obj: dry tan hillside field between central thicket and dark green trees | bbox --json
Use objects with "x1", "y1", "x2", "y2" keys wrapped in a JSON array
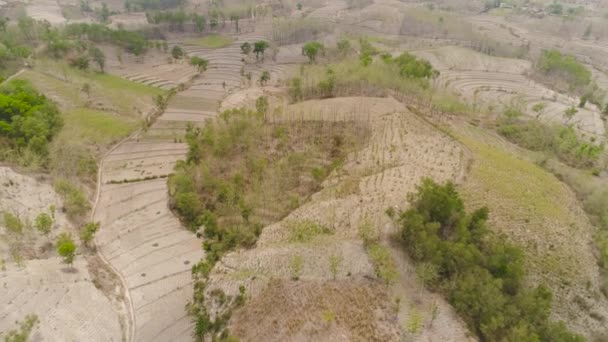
[{"x1": 207, "y1": 98, "x2": 467, "y2": 341}]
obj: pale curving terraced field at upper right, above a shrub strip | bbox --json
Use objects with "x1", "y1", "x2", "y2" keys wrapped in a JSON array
[{"x1": 415, "y1": 47, "x2": 606, "y2": 138}]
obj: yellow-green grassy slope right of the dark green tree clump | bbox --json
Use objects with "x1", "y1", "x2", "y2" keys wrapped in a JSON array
[{"x1": 453, "y1": 127, "x2": 589, "y2": 282}]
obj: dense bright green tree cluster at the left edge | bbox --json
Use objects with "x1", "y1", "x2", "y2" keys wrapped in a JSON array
[{"x1": 0, "y1": 80, "x2": 63, "y2": 164}]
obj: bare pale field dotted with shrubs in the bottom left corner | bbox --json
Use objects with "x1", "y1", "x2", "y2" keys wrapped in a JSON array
[{"x1": 0, "y1": 167, "x2": 122, "y2": 341}]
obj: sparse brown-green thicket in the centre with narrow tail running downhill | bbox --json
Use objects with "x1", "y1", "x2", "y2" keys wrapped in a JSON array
[{"x1": 175, "y1": 106, "x2": 368, "y2": 341}]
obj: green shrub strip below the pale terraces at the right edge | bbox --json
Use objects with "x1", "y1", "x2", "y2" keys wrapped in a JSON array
[{"x1": 498, "y1": 109, "x2": 604, "y2": 167}]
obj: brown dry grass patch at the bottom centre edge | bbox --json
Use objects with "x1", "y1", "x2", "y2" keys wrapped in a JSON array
[{"x1": 229, "y1": 279, "x2": 399, "y2": 341}]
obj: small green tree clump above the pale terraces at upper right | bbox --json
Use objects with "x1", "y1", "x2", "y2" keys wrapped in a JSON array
[{"x1": 537, "y1": 50, "x2": 591, "y2": 93}]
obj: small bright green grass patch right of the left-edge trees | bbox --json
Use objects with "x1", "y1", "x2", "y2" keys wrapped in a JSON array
[{"x1": 61, "y1": 108, "x2": 138, "y2": 144}]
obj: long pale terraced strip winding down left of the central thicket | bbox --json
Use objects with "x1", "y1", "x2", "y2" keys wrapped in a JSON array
[{"x1": 94, "y1": 22, "x2": 276, "y2": 341}]
